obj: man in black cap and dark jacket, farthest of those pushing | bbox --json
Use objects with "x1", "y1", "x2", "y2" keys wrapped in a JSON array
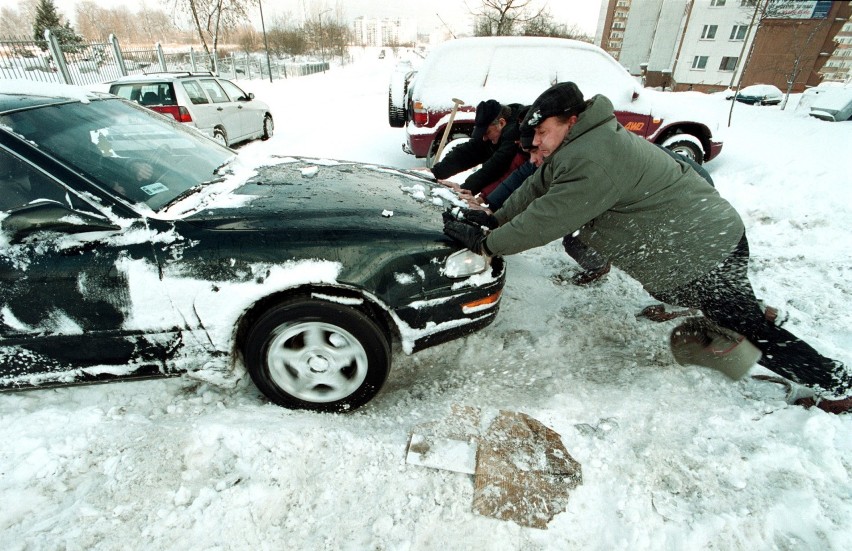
[{"x1": 432, "y1": 99, "x2": 527, "y2": 195}]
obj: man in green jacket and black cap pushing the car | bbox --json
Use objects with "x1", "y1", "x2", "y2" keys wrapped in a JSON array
[{"x1": 444, "y1": 82, "x2": 852, "y2": 413}]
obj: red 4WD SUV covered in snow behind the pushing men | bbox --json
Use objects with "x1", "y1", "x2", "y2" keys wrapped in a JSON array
[{"x1": 388, "y1": 37, "x2": 722, "y2": 164}]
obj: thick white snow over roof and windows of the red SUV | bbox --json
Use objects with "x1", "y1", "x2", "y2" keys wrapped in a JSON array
[{"x1": 414, "y1": 37, "x2": 639, "y2": 109}]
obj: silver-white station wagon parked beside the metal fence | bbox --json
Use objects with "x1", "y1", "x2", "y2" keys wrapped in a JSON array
[{"x1": 109, "y1": 72, "x2": 275, "y2": 146}]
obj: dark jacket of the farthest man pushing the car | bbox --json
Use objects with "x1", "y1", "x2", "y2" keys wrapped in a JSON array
[{"x1": 432, "y1": 103, "x2": 526, "y2": 195}]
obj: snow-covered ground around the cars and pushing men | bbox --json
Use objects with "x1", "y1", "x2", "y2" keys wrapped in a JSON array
[{"x1": 0, "y1": 49, "x2": 852, "y2": 551}]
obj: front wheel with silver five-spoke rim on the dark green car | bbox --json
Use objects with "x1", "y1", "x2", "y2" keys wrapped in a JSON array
[{"x1": 243, "y1": 299, "x2": 391, "y2": 411}]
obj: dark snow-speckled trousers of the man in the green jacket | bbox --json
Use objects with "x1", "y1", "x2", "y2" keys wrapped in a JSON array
[{"x1": 654, "y1": 235, "x2": 852, "y2": 398}]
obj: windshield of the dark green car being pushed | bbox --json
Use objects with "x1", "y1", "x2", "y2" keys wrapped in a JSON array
[{"x1": 0, "y1": 99, "x2": 234, "y2": 210}]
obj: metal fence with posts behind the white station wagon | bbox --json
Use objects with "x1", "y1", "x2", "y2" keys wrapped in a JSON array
[{"x1": 0, "y1": 30, "x2": 329, "y2": 86}]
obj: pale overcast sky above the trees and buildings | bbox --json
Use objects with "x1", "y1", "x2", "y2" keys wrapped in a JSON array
[{"x1": 50, "y1": 0, "x2": 601, "y2": 36}]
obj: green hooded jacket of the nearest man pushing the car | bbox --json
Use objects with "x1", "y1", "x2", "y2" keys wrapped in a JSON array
[{"x1": 486, "y1": 95, "x2": 745, "y2": 294}]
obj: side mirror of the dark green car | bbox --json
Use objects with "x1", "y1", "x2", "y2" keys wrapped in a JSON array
[{"x1": 0, "y1": 199, "x2": 121, "y2": 241}]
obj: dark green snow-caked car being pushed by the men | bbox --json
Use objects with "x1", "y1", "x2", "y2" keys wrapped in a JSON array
[{"x1": 0, "y1": 80, "x2": 505, "y2": 411}]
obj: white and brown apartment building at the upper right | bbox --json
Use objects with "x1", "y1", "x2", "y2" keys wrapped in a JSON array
[{"x1": 596, "y1": 0, "x2": 852, "y2": 92}]
